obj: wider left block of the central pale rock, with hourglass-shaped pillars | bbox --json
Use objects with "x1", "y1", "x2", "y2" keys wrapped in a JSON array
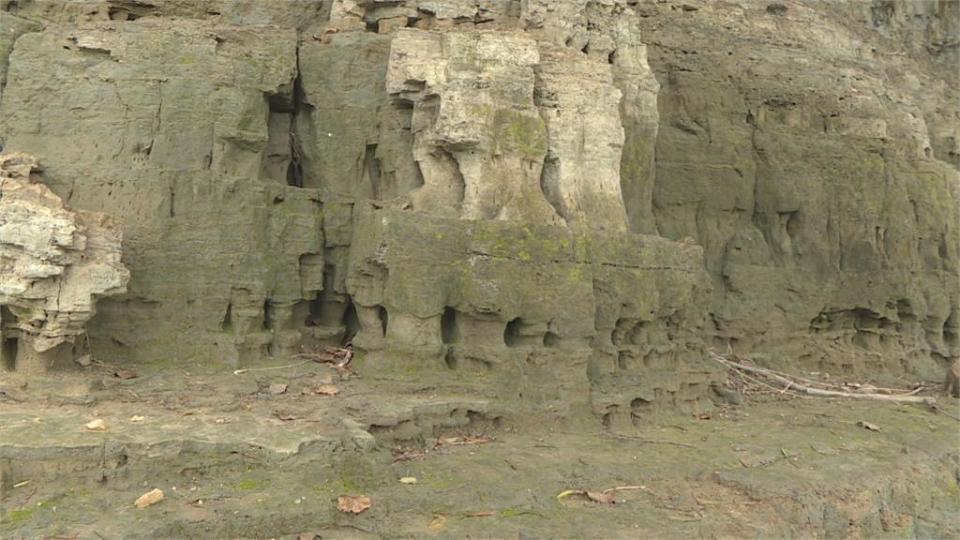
[{"x1": 387, "y1": 30, "x2": 560, "y2": 223}]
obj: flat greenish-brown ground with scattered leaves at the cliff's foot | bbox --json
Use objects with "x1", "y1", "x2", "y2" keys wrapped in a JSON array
[{"x1": 0, "y1": 358, "x2": 960, "y2": 539}]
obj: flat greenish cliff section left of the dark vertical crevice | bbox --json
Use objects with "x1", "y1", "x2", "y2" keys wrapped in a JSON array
[{"x1": 0, "y1": 19, "x2": 323, "y2": 370}]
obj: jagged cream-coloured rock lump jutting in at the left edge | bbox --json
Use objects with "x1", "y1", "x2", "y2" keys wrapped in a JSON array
[{"x1": 0, "y1": 154, "x2": 130, "y2": 367}]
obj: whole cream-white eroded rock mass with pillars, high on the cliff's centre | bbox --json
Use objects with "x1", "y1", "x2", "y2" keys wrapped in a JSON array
[{"x1": 386, "y1": 24, "x2": 640, "y2": 231}]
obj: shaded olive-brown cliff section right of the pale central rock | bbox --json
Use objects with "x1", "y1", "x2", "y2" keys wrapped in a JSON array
[{"x1": 637, "y1": 1, "x2": 960, "y2": 378}]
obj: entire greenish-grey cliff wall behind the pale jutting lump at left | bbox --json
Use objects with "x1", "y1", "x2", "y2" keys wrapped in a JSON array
[{"x1": 0, "y1": 0, "x2": 960, "y2": 423}]
